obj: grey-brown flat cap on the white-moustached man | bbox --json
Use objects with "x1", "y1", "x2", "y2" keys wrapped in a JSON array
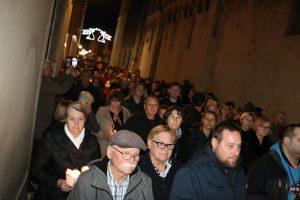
[{"x1": 110, "y1": 130, "x2": 147, "y2": 151}]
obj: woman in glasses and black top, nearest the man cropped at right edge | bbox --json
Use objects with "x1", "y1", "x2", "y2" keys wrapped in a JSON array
[{"x1": 242, "y1": 117, "x2": 272, "y2": 171}]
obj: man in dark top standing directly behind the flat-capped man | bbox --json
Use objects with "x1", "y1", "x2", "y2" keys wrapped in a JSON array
[{"x1": 123, "y1": 96, "x2": 160, "y2": 142}]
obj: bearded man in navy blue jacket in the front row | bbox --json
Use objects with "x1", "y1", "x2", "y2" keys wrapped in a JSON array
[{"x1": 170, "y1": 121, "x2": 246, "y2": 200}]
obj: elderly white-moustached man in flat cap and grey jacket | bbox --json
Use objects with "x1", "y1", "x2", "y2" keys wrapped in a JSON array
[{"x1": 68, "y1": 130, "x2": 153, "y2": 200}]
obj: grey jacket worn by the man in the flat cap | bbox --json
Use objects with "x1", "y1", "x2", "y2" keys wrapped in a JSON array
[{"x1": 68, "y1": 157, "x2": 153, "y2": 200}]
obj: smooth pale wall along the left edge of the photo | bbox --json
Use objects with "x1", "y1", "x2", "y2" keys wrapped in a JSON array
[{"x1": 0, "y1": 0, "x2": 55, "y2": 199}]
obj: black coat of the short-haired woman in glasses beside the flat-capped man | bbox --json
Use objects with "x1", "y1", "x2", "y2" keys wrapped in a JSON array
[{"x1": 139, "y1": 154, "x2": 181, "y2": 200}]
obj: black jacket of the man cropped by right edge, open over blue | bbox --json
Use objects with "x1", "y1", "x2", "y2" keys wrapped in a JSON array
[{"x1": 247, "y1": 148, "x2": 289, "y2": 200}]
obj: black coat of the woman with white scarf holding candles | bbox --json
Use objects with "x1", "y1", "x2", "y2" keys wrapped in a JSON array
[{"x1": 31, "y1": 126, "x2": 100, "y2": 200}]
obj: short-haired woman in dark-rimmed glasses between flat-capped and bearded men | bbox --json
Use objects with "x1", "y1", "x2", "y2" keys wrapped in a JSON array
[{"x1": 139, "y1": 125, "x2": 181, "y2": 200}]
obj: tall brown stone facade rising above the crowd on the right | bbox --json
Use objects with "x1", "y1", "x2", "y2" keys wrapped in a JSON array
[{"x1": 113, "y1": 0, "x2": 300, "y2": 122}]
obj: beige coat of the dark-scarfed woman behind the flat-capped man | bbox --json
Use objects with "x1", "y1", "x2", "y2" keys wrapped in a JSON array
[{"x1": 96, "y1": 106, "x2": 130, "y2": 157}]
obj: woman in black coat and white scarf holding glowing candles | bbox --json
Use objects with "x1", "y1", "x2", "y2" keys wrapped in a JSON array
[{"x1": 31, "y1": 102, "x2": 100, "y2": 200}]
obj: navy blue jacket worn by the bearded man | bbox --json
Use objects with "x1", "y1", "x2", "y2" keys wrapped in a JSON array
[{"x1": 170, "y1": 144, "x2": 246, "y2": 200}]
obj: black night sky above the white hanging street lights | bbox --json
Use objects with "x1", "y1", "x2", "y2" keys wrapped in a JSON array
[{"x1": 83, "y1": 0, "x2": 122, "y2": 35}]
